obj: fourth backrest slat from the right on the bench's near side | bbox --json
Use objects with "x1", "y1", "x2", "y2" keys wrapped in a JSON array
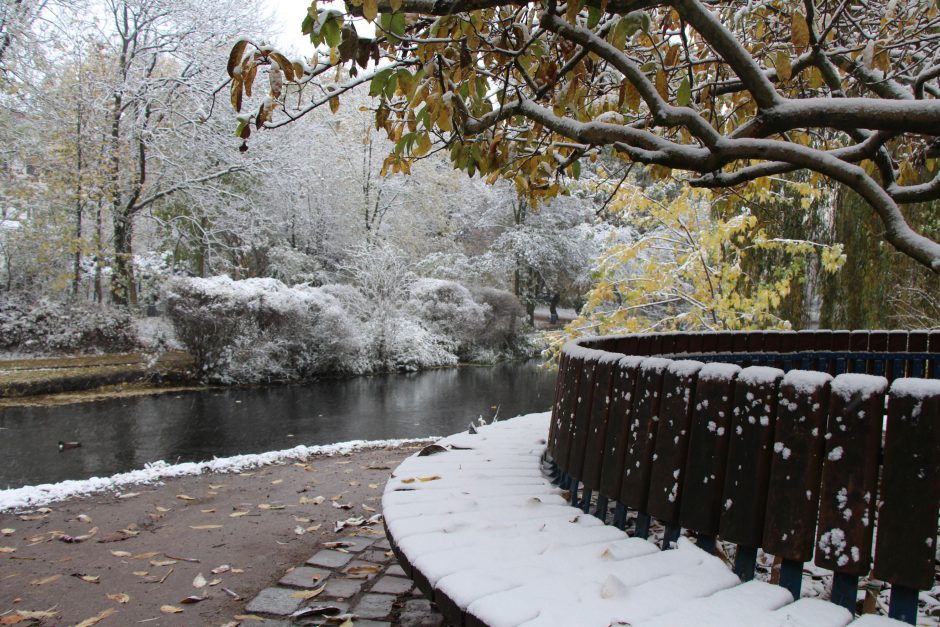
[{"x1": 719, "y1": 366, "x2": 783, "y2": 548}]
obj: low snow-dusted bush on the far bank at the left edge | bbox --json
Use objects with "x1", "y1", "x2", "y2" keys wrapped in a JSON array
[{"x1": 0, "y1": 294, "x2": 138, "y2": 354}]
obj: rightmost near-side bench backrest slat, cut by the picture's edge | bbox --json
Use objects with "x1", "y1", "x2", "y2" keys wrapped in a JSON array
[{"x1": 875, "y1": 379, "x2": 940, "y2": 590}]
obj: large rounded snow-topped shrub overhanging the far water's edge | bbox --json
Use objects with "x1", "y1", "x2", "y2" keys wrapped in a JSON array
[{"x1": 165, "y1": 276, "x2": 365, "y2": 383}]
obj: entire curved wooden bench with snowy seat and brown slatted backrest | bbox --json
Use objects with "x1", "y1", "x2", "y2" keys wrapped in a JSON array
[{"x1": 383, "y1": 332, "x2": 940, "y2": 626}]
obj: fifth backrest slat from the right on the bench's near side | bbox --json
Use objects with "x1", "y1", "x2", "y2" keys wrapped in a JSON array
[{"x1": 679, "y1": 364, "x2": 741, "y2": 535}]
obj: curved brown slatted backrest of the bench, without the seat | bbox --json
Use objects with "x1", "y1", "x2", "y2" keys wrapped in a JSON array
[{"x1": 549, "y1": 331, "x2": 940, "y2": 621}]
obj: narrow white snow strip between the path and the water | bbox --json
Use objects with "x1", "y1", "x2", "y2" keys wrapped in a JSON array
[{"x1": 0, "y1": 436, "x2": 439, "y2": 512}]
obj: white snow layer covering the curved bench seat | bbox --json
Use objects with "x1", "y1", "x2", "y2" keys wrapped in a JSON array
[{"x1": 382, "y1": 413, "x2": 860, "y2": 627}]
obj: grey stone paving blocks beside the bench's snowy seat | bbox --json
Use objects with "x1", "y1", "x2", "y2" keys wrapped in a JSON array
[{"x1": 241, "y1": 529, "x2": 444, "y2": 627}]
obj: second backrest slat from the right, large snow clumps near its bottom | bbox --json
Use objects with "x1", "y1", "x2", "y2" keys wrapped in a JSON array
[{"x1": 815, "y1": 374, "x2": 887, "y2": 576}]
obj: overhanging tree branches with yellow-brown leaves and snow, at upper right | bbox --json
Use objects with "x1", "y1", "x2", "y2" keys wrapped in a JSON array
[{"x1": 228, "y1": 0, "x2": 940, "y2": 272}]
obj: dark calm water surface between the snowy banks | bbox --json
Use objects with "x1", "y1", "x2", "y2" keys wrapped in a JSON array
[{"x1": 0, "y1": 362, "x2": 555, "y2": 489}]
